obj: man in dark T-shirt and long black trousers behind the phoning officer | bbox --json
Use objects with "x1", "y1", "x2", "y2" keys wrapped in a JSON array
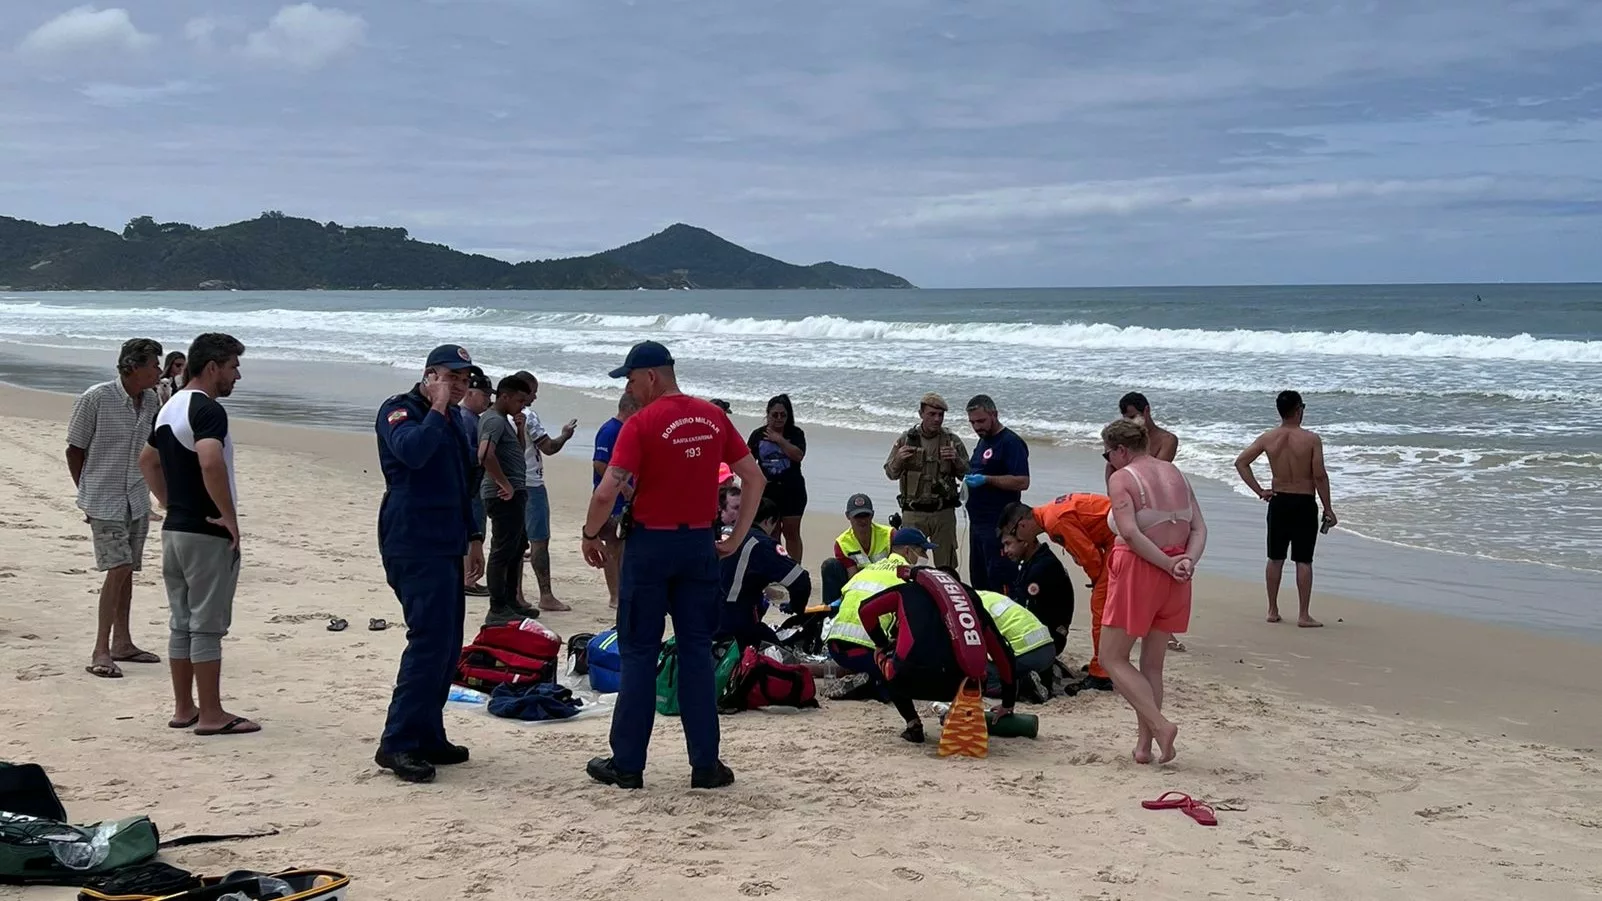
[{"x1": 477, "y1": 375, "x2": 540, "y2": 625}]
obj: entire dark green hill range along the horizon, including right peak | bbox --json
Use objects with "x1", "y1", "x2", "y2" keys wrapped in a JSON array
[{"x1": 0, "y1": 212, "x2": 912, "y2": 290}]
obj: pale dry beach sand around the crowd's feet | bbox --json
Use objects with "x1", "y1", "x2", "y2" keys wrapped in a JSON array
[{"x1": 0, "y1": 380, "x2": 1602, "y2": 901}]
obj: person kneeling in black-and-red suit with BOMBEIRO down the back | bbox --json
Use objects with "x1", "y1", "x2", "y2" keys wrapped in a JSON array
[{"x1": 862, "y1": 568, "x2": 1012, "y2": 744}]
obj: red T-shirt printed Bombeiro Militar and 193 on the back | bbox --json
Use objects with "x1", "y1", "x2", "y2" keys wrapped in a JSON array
[{"x1": 610, "y1": 394, "x2": 751, "y2": 529}]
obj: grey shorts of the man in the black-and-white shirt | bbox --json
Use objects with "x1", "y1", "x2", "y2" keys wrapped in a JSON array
[{"x1": 162, "y1": 531, "x2": 239, "y2": 664}]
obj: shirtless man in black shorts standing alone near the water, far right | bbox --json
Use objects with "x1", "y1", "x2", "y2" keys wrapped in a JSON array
[{"x1": 1235, "y1": 391, "x2": 1339, "y2": 628}]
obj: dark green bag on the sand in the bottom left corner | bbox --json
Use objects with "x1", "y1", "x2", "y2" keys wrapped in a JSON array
[{"x1": 0, "y1": 811, "x2": 160, "y2": 885}]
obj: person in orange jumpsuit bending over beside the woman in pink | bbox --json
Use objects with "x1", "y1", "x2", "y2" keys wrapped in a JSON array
[{"x1": 1000, "y1": 494, "x2": 1117, "y2": 691}]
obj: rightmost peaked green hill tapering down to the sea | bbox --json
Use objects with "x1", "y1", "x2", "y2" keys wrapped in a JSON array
[{"x1": 601, "y1": 223, "x2": 913, "y2": 289}]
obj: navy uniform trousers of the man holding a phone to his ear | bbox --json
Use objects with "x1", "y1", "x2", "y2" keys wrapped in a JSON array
[{"x1": 378, "y1": 556, "x2": 468, "y2": 754}]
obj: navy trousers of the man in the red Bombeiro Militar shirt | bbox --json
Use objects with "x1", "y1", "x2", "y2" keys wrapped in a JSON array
[{"x1": 612, "y1": 526, "x2": 721, "y2": 773}]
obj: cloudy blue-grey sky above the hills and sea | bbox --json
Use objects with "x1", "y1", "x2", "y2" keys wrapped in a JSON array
[{"x1": 0, "y1": 0, "x2": 1602, "y2": 287}]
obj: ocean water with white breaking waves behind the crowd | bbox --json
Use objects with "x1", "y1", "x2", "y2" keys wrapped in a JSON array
[{"x1": 0, "y1": 285, "x2": 1602, "y2": 571}]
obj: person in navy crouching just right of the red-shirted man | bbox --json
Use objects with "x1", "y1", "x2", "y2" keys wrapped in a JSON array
[{"x1": 713, "y1": 497, "x2": 812, "y2": 648}]
